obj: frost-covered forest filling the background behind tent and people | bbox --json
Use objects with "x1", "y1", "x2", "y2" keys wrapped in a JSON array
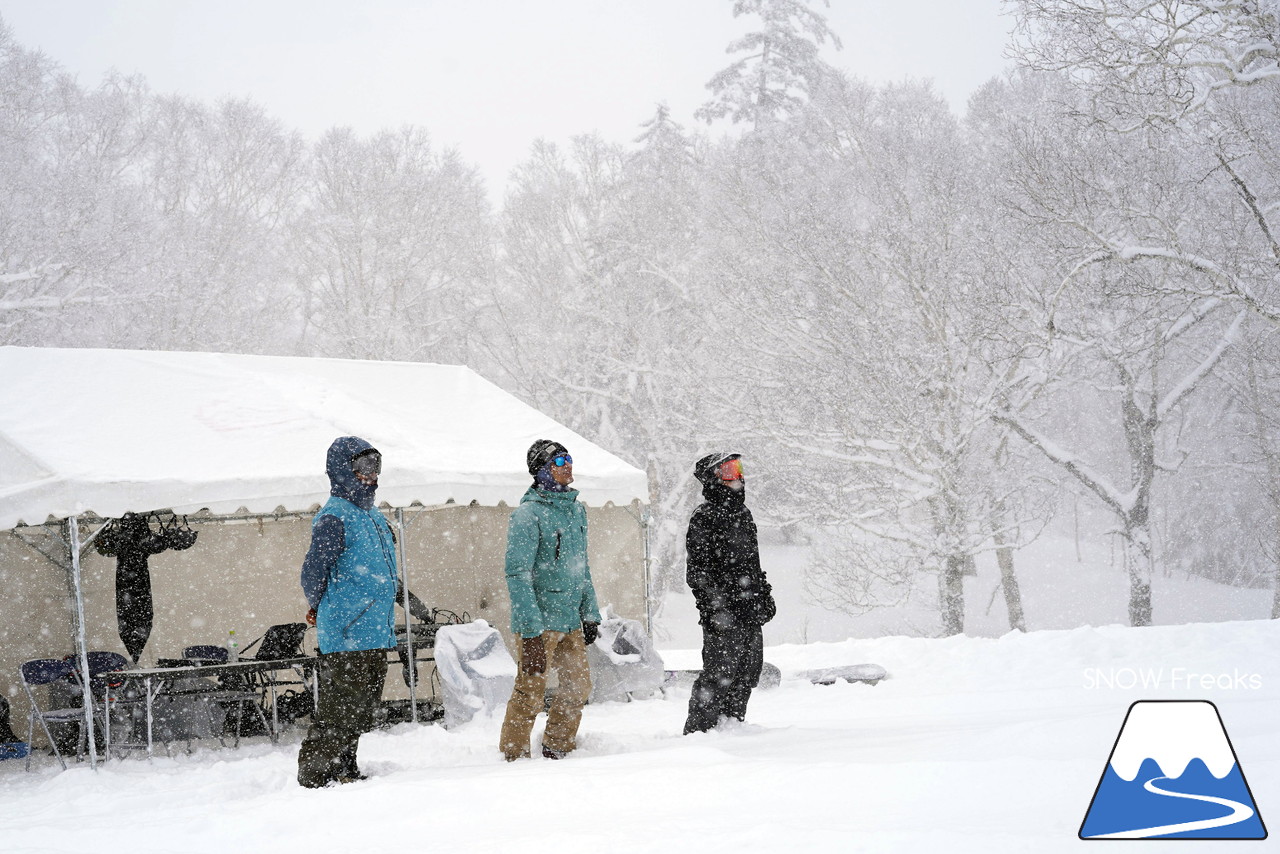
[{"x1": 0, "y1": 0, "x2": 1280, "y2": 634}]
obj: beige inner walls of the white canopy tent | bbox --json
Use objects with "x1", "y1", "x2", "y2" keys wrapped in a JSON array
[{"x1": 0, "y1": 502, "x2": 645, "y2": 743}]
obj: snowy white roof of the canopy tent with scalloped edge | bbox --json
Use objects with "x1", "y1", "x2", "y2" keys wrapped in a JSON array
[{"x1": 0, "y1": 347, "x2": 648, "y2": 530}]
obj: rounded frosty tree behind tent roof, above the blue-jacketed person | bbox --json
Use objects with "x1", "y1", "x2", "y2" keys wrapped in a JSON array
[{"x1": 293, "y1": 128, "x2": 490, "y2": 362}]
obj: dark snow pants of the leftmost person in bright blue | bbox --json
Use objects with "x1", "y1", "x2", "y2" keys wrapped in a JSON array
[{"x1": 298, "y1": 649, "x2": 387, "y2": 789}]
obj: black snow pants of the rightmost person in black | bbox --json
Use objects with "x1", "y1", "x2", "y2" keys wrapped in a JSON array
[{"x1": 685, "y1": 625, "x2": 764, "y2": 735}]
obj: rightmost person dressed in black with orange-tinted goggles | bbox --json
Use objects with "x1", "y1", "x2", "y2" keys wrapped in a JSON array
[{"x1": 685, "y1": 453, "x2": 777, "y2": 735}]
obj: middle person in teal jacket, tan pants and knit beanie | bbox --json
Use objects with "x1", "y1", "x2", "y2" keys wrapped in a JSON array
[{"x1": 499, "y1": 439, "x2": 600, "y2": 762}]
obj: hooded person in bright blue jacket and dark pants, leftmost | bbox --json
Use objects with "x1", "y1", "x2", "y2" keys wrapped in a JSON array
[{"x1": 298, "y1": 437, "x2": 430, "y2": 789}]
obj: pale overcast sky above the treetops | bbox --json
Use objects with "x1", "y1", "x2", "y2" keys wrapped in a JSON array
[{"x1": 0, "y1": 0, "x2": 1010, "y2": 197}]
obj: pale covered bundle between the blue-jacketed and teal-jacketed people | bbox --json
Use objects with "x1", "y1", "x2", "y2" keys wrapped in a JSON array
[{"x1": 435, "y1": 620, "x2": 516, "y2": 729}]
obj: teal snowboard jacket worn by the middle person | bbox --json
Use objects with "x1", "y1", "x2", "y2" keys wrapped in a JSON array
[{"x1": 507, "y1": 487, "x2": 600, "y2": 638}]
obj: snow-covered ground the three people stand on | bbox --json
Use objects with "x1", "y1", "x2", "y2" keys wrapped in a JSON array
[{"x1": 0, "y1": 530, "x2": 1280, "y2": 854}]
